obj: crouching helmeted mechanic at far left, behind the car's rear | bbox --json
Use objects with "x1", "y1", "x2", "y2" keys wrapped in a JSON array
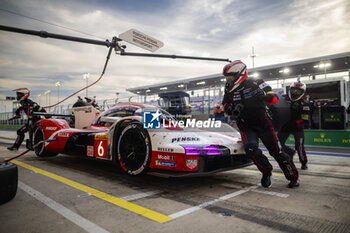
[{"x1": 7, "y1": 88, "x2": 46, "y2": 150}]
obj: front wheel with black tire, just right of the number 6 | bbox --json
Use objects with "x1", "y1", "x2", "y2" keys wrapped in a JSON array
[{"x1": 117, "y1": 122, "x2": 152, "y2": 176}]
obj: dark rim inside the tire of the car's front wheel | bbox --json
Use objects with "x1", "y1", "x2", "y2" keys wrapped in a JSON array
[{"x1": 119, "y1": 128, "x2": 147, "y2": 171}]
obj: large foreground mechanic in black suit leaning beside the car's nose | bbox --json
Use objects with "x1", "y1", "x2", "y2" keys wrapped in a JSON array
[{"x1": 222, "y1": 60, "x2": 299, "y2": 188}]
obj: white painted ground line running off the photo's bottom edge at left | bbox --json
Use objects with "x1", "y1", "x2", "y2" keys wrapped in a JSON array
[{"x1": 18, "y1": 181, "x2": 109, "y2": 233}]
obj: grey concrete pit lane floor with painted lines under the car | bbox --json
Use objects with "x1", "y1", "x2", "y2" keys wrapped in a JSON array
[{"x1": 0, "y1": 131, "x2": 350, "y2": 232}]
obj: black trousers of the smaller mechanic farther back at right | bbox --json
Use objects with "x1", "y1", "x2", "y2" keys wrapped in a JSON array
[{"x1": 278, "y1": 121, "x2": 307, "y2": 165}]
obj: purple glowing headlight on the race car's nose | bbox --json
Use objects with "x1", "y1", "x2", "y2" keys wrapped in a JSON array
[{"x1": 182, "y1": 145, "x2": 230, "y2": 155}]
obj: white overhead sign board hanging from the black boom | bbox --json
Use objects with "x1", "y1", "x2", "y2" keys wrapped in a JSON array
[{"x1": 119, "y1": 29, "x2": 164, "y2": 52}]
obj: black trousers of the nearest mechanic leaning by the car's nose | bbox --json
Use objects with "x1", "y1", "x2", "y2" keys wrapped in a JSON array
[{"x1": 237, "y1": 117, "x2": 298, "y2": 181}]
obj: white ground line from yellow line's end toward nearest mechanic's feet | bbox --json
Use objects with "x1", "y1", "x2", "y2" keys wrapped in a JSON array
[{"x1": 169, "y1": 185, "x2": 259, "y2": 218}]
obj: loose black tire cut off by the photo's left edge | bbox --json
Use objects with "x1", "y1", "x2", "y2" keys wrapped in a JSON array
[{"x1": 0, "y1": 163, "x2": 18, "y2": 205}]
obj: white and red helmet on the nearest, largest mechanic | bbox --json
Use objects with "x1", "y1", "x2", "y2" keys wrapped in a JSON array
[{"x1": 222, "y1": 60, "x2": 248, "y2": 92}]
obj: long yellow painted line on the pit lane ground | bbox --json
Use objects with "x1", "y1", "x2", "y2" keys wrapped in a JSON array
[{"x1": 12, "y1": 160, "x2": 172, "y2": 223}]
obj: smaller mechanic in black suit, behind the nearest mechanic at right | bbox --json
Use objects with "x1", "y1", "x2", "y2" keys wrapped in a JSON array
[{"x1": 278, "y1": 81, "x2": 307, "y2": 170}]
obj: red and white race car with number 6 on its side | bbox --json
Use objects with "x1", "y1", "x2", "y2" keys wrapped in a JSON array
[{"x1": 32, "y1": 103, "x2": 252, "y2": 177}]
